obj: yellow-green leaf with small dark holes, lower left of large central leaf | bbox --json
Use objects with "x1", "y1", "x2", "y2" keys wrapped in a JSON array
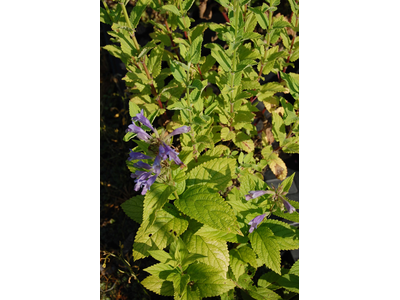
[{"x1": 133, "y1": 206, "x2": 189, "y2": 261}]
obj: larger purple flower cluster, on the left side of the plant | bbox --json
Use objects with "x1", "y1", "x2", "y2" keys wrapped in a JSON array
[{"x1": 127, "y1": 110, "x2": 190, "y2": 195}]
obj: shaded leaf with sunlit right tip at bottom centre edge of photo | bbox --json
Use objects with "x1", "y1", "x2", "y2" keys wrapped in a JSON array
[{"x1": 186, "y1": 263, "x2": 235, "y2": 298}]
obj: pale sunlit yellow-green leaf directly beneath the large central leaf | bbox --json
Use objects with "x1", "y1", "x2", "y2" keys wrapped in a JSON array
[{"x1": 185, "y1": 234, "x2": 229, "y2": 278}]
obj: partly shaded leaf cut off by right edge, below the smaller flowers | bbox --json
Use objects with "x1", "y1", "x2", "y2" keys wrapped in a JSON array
[{"x1": 263, "y1": 219, "x2": 299, "y2": 250}]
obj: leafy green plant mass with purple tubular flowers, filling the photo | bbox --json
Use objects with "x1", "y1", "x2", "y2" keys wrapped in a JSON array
[{"x1": 101, "y1": 0, "x2": 299, "y2": 299}]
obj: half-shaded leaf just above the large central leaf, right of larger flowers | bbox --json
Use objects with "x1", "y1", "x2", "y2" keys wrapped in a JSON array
[{"x1": 186, "y1": 158, "x2": 236, "y2": 190}]
